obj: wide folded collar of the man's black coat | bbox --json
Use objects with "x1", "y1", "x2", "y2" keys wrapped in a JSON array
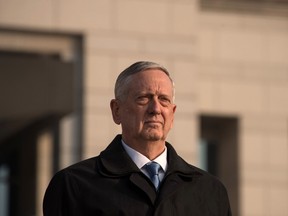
[{"x1": 98, "y1": 135, "x2": 201, "y2": 203}]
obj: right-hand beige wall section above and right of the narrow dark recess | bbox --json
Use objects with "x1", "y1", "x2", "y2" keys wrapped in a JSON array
[{"x1": 197, "y1": 12, "x2": 288, "y2": 216}]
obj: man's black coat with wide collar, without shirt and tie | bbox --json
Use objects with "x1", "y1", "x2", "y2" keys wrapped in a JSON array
[{"x1": 43, "y1": 135, "x2": 231, "y2": 216}]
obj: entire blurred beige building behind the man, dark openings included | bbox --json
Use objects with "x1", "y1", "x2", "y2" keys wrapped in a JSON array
[{"x1": 0, "y1": 0, "x2": 288, "y2": 216}]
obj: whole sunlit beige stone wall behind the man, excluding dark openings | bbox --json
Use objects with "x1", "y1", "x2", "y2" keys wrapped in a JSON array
[{"x1": 0, "y1": 0, "x2": 288, "y2": 216}]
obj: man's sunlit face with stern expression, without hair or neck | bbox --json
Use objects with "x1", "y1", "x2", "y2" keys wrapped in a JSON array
[{"x1": 112, "y1": 69, "x2": 176, "y2": 142}]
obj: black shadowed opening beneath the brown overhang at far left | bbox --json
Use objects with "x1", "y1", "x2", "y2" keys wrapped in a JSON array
[{"x1": 0, "y1": 116, "x2": 59, "y2": 216}]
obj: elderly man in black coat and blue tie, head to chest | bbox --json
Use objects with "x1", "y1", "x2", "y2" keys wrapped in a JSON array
[{"x1": 43, "y1": 62, "x2": 231, "y2": 216}]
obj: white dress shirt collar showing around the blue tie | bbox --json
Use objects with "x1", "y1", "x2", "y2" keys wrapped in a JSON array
[{"x1": 122, "y1": 140, "x2": 167, "y2": 182}]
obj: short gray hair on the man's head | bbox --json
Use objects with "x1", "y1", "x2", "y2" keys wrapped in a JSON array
[{"x1": 114, "y1": 61, "x2": 175, "y2": 101}]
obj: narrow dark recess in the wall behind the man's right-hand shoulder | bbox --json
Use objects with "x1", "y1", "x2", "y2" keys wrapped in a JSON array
[{"x1": 200, "y1": 116, "x2": 239, "y2": 216}]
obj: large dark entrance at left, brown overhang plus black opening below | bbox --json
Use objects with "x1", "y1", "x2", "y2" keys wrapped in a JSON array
[{"x1": 0, "y1": 51, "x2": 74, "y2": 216}]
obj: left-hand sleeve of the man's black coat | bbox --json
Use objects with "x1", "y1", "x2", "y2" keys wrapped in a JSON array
[{"x1": 43, "y1": 171, "x2": 81, "y2": 216}]
